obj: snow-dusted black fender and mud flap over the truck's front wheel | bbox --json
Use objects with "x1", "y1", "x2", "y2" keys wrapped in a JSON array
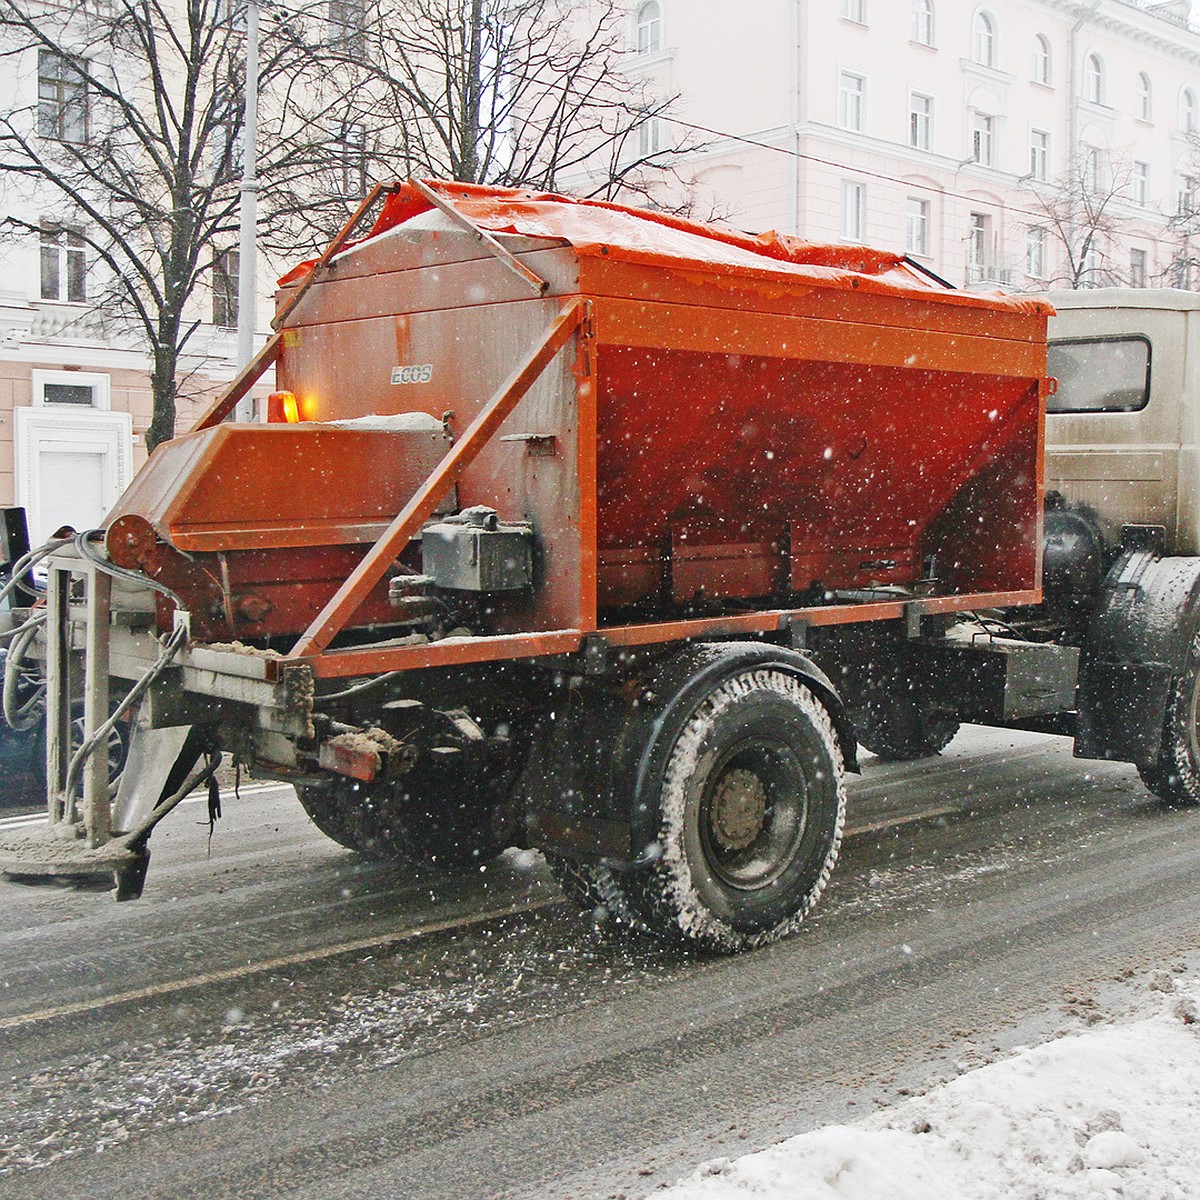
[{"x1": 1075, "y1": 550, "x2": 1200, "y2": 772}]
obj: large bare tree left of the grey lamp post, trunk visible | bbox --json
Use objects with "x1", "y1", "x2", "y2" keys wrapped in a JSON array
[{"x1": 0, "y1": 0, "x2": 350, "y2": 448}]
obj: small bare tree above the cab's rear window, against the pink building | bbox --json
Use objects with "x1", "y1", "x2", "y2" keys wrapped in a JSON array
[{"x1": 1027, "y1": 148, "x2": 1132, "y2": 289}]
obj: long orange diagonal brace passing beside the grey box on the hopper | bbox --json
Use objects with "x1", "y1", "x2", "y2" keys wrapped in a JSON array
[{"x1": 288, "y1": 299, "x2": 587, "y2": 659}]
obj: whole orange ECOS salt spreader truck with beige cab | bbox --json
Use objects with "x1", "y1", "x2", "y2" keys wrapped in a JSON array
[{"x1": 0, "y1": 181, "x2": 1200, "y2": 950}]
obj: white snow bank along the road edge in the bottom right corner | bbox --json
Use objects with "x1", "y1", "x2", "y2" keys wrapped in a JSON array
[{"x1": 655, "y1": 972, "x2": 1200, "y2": 1200}]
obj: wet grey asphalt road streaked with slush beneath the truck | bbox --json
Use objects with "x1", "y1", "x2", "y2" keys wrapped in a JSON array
[{"x1": 0, "y1": 730, "x2": 1200, "y2": 1200}]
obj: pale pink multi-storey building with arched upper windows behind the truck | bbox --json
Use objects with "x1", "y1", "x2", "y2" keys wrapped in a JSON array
[{"x1": 614, "y1": 0, "x2": 1200, "y2": 290}]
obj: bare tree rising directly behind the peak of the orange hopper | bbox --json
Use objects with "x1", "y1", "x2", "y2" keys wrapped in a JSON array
[{"x1": 290, "y1": 0, "x2": 694, "y2": 212}]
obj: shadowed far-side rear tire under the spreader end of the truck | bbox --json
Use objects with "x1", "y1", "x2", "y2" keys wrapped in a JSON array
[{"x1": 295, "y1": 761, "x2": 516, "y2": 870}]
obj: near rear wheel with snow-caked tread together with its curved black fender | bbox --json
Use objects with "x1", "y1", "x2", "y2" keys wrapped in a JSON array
[{"x1": 526, "y1": 642, "x2": 854, "y2": 952}]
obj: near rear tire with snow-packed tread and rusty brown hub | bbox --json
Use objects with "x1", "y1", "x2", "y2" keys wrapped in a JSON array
[{"x1": 626, "y1": 664, "x2": 846, "y2": 953}]
